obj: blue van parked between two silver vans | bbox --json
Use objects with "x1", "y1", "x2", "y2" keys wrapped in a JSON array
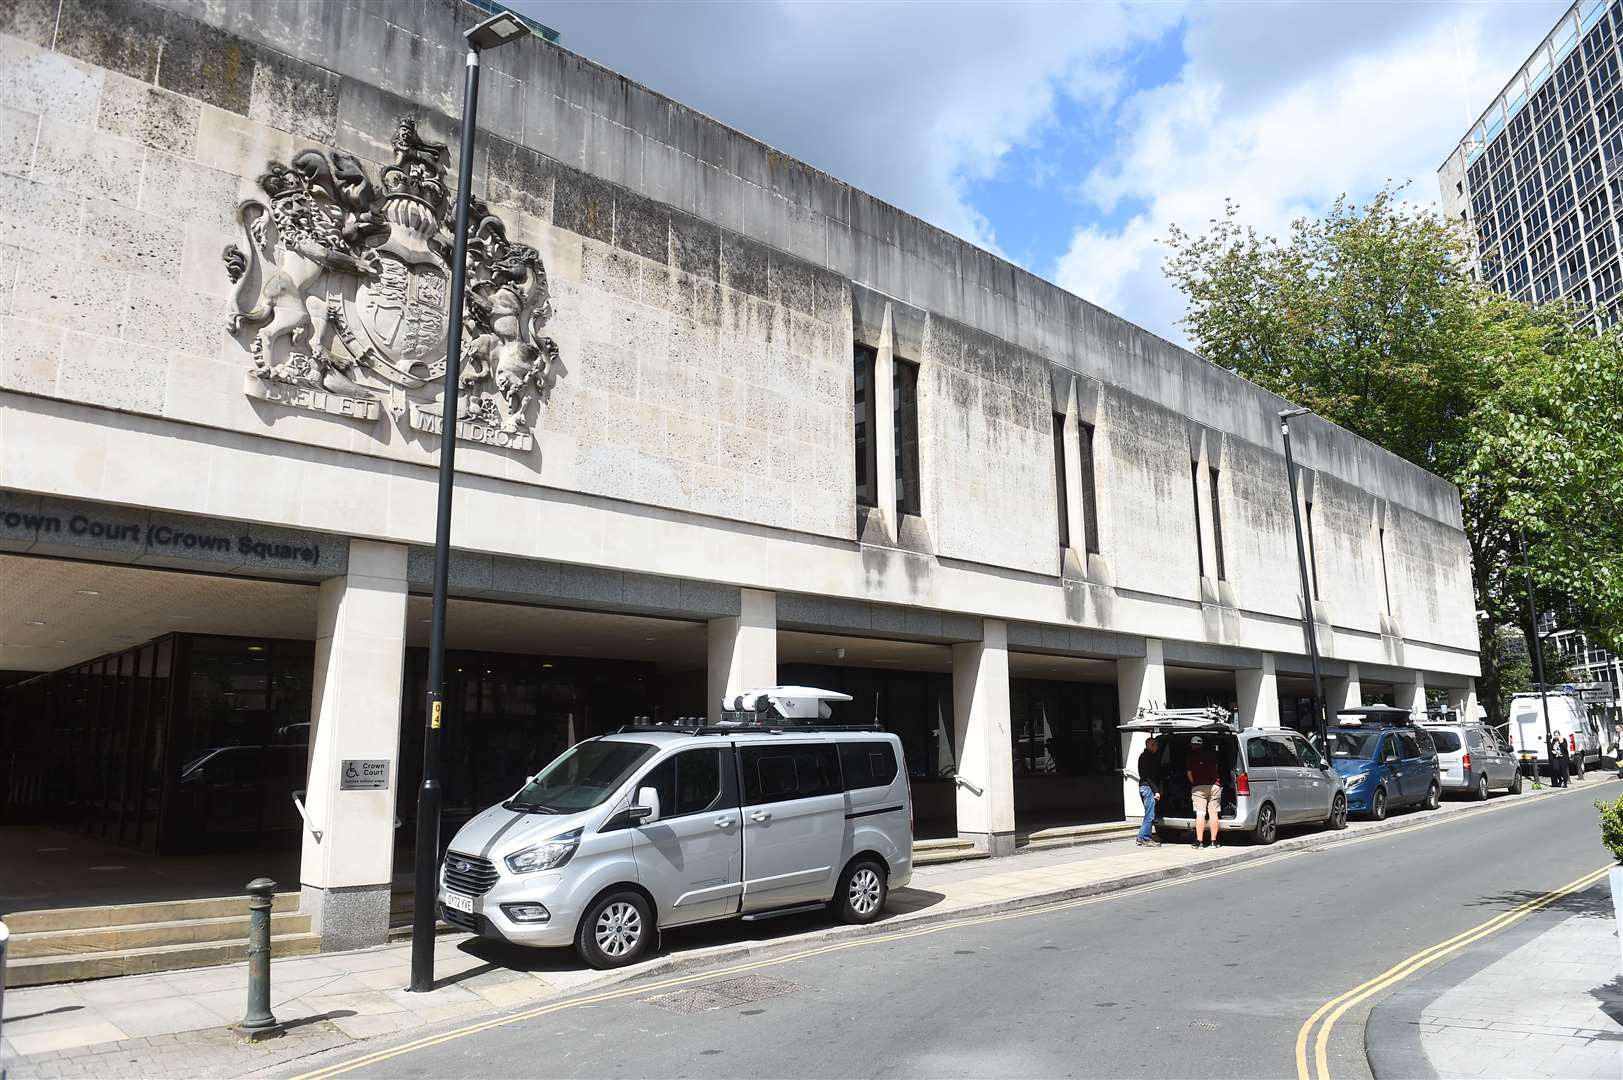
[{"x1": 1328, "y1": 705, "x2": 1443, "y2": 822}]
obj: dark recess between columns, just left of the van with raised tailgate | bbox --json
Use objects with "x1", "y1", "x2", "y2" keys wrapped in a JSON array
[{"x1": 1010, "y1": 679, "x2": 1121, "y2": 832}]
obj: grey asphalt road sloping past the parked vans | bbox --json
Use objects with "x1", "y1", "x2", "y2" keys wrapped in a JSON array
[{"x1": 322, "y1": 781, "x2": 1618, "y2": 1078}]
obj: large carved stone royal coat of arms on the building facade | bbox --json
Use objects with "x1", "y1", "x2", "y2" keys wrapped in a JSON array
[{"x1": 224, "y1": 117, "x2": 562, "y2": 450}]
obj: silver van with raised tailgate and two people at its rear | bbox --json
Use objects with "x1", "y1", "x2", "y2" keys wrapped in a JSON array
[{"x1": 1121, "y1": 708, "x2": 1347, "y2": 845}]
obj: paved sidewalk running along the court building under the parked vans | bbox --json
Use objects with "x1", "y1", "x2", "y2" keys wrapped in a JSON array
[{"x1": 0, "y1": 783, "x2": 1615, "y2": 1080}]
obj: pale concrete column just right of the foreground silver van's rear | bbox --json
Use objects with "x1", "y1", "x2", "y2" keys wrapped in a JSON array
[{"x1": 953, "y1": 619, "x2": 1014, "y2": 856}]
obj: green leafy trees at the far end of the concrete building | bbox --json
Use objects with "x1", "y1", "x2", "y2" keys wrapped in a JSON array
[{"x1": 1165, "y1": 188, "x2": 1623, "y2": 715}]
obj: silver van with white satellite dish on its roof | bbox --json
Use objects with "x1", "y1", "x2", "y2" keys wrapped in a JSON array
[{"x1": 440, "y1": 687, "x2": 912, "y2": 968}]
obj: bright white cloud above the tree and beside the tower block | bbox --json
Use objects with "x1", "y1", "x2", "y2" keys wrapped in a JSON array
[{"x1": 1053, "y1": 3, "x2": 1566, "y2": 339}]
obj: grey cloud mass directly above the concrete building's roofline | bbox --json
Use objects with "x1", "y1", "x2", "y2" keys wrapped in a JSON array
[{"x1": 508, "y1": 0, "x2": 1178, "y2": 247}]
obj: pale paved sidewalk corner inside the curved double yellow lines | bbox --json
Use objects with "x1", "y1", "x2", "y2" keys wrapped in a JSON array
[{"x1": 1420, "y1": 882, "x2": 1623, "y2": 1080}]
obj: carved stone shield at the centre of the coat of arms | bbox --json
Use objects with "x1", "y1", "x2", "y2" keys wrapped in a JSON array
[{"x1": 346, "y1": 245, "x2": 451, "y2": 390}]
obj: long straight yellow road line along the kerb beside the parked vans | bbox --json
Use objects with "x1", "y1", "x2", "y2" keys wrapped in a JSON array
[{"x1": 294, "y1": 851, "x2": 1302, "y2": 1080}]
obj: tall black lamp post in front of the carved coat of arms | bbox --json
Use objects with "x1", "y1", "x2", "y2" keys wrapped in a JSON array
[{"x1": 409, "y1": 11, "x2": 529, "y2": 994}]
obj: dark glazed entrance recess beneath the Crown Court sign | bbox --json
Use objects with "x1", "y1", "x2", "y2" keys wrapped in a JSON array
[{"x1": 0, "y1": 633, "x2": 315, "y2": 854}]
